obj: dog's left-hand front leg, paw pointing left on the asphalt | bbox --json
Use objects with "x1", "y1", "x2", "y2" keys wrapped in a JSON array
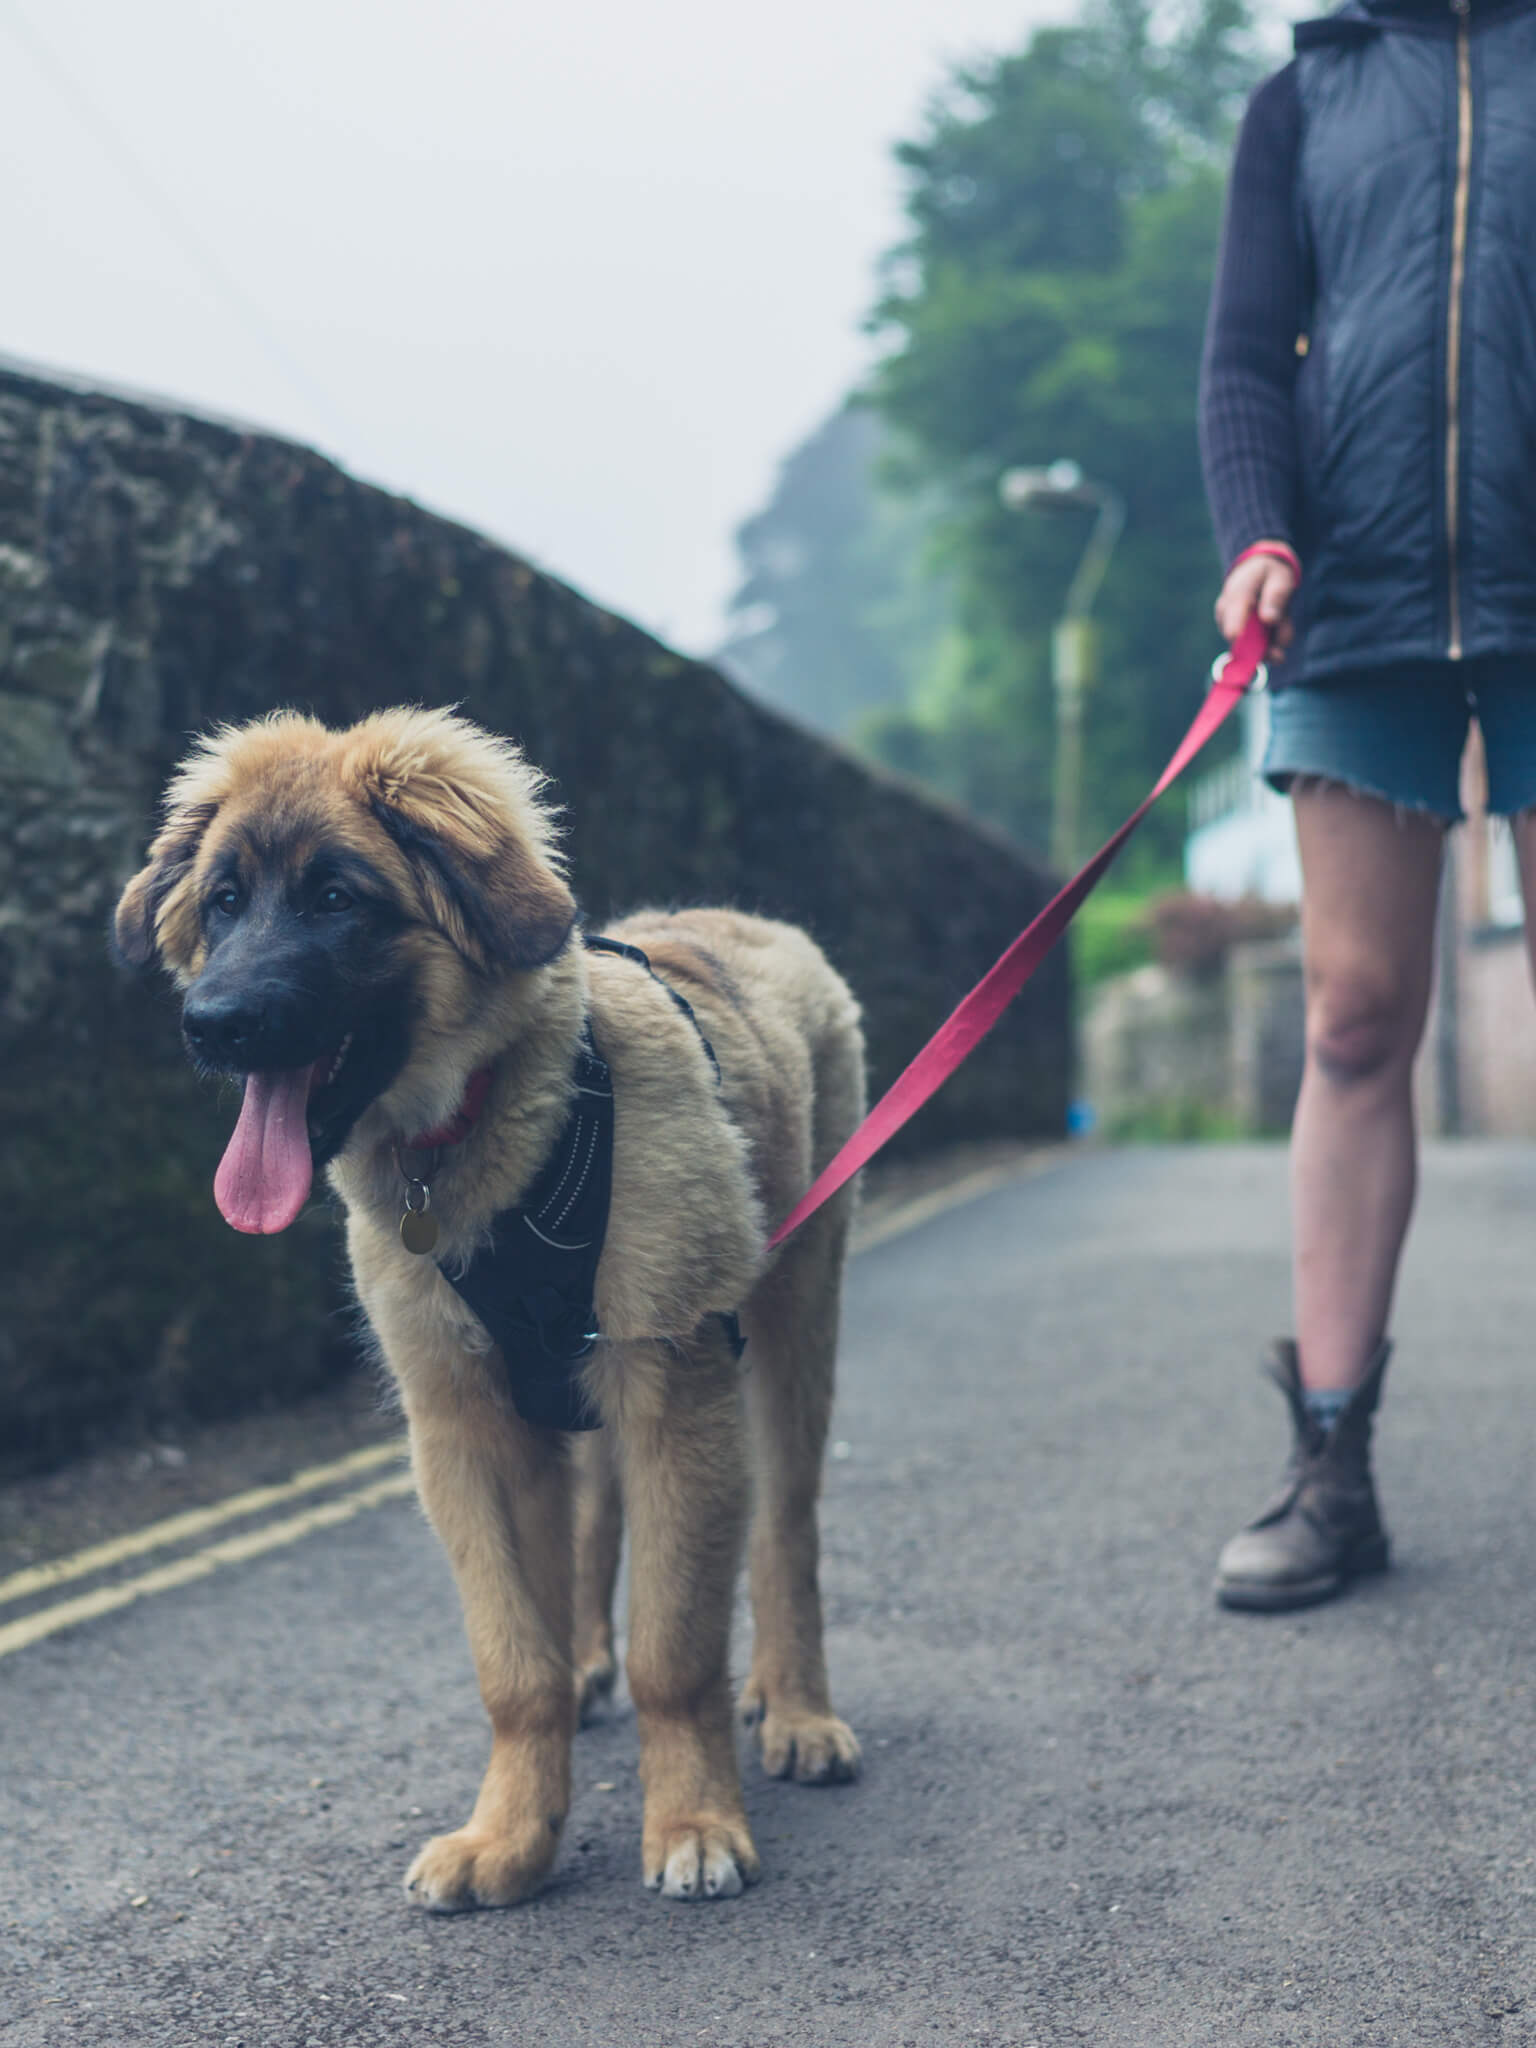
[{"x1": 403, "y1": 1372, "x2": 575, "y2": 1913}]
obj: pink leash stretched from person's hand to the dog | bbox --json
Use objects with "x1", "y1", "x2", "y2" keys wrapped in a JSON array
[{"x1": 768, "y1": 606, "x2": 1270, "y2": 1251}]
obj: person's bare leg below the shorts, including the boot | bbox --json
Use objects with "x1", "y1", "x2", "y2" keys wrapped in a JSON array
[{"x1": 1217, "y1": 780, "x2": 1444, "y2": 1612}]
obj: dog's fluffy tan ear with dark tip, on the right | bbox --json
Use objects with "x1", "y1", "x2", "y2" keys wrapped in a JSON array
[{"x1": 365, "y1": 711, "x2": 575, "y2": 971}]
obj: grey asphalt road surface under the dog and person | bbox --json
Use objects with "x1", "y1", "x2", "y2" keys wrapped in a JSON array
[{"x1": 0, "y1": 1145, "x2": 1536, "y2": 2048}]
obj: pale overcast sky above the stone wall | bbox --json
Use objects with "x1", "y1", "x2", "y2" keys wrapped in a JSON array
[{"x1": 0, "y1": 0, "x2": 1067, "y2": 651}]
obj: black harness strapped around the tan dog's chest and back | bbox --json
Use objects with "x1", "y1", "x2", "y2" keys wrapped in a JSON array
[{"x1": 438, "y1": 938, "x2": 745, "y2": 1430}]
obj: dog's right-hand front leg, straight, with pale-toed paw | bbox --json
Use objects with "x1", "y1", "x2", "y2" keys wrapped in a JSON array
[{"x1": 598, "y1": 1317, "x2": 758, "y2": 1898}]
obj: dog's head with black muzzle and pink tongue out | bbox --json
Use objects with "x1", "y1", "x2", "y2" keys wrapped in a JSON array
[{"x1": 115, "y1": 711, "x2": 575, "y2": 1233}]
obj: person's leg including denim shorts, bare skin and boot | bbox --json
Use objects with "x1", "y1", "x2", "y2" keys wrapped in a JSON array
[{"x1": 1217, "y1": 662, "x2": 1468, "y2": 1610}]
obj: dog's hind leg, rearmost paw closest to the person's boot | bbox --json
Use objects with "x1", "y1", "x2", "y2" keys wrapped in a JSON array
[{"x1": 741, "y1": 1192, "x2": 858, "y2": 1784}]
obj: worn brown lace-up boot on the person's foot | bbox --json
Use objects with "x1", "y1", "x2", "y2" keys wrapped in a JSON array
[{"x1": 1217, "y1": 1341, "x2": 1393, "y2": 1612}]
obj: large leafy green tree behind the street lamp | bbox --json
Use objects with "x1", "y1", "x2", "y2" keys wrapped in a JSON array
[{"x1": 864, "y1": 0, "x2": 1257, "y2": 858}]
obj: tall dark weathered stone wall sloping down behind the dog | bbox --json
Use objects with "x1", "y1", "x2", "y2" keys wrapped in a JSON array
[{"x1": 0, "y1": 367, "x2": 1069, "y2": 1468}]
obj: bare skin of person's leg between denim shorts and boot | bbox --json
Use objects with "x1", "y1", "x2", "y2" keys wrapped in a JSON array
[{"x1": 1290, "y1": 782, "x2": 1444, "y2": 1389}]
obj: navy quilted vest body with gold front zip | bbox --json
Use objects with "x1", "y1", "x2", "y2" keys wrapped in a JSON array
[{"x1": 1296, "y1": 0, "x2": 1536, "y2": 680}]
